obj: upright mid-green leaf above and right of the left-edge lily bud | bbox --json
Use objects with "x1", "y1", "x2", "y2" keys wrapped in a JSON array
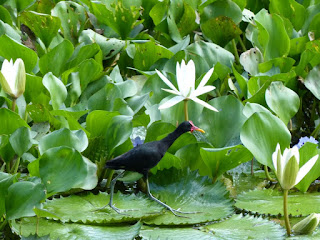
[{"x1": 39, "y1": 40, "x2": 73, "y2": 77}]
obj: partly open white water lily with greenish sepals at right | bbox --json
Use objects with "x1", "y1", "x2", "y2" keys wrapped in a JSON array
[{"x1": 272, "y1": 143, "x2": 319, "y2": 190}]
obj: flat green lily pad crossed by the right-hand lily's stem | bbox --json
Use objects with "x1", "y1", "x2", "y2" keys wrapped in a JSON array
[{"x1": 235, "y1": 189, "x2": 320, "y2": 216}]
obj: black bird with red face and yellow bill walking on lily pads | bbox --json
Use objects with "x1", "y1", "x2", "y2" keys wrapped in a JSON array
[{"x1": 105, "y1": 121, "x2": 204, "y2": 217}]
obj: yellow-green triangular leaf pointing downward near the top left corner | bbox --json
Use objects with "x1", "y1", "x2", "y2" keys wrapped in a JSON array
[{"x1": 20, "y1": 11, "x2": 61, "y2": 48}]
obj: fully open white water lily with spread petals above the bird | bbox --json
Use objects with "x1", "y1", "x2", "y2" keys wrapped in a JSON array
[{"x1": 156, "y1": 60, "x2": 218, "y2": 112}]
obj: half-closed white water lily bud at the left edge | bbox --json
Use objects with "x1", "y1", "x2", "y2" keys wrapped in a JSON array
[{"x1": 0, "y1": 58, "x2": 26, "y2": 98}]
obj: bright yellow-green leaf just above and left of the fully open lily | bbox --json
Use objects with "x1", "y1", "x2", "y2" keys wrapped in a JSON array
[{"x1": 133, "y1": 41, "x2": 173, "y2": 70}]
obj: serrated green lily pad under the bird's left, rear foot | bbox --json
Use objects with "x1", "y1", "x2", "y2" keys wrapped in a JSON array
[{"x1": 44, "y1": 192, "x2": 163, "y2": 224}]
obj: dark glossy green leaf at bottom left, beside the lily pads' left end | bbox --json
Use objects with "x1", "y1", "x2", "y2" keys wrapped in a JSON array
[{"x1": 6, "y1": 182, "x2": 46, "y2": 220}]
